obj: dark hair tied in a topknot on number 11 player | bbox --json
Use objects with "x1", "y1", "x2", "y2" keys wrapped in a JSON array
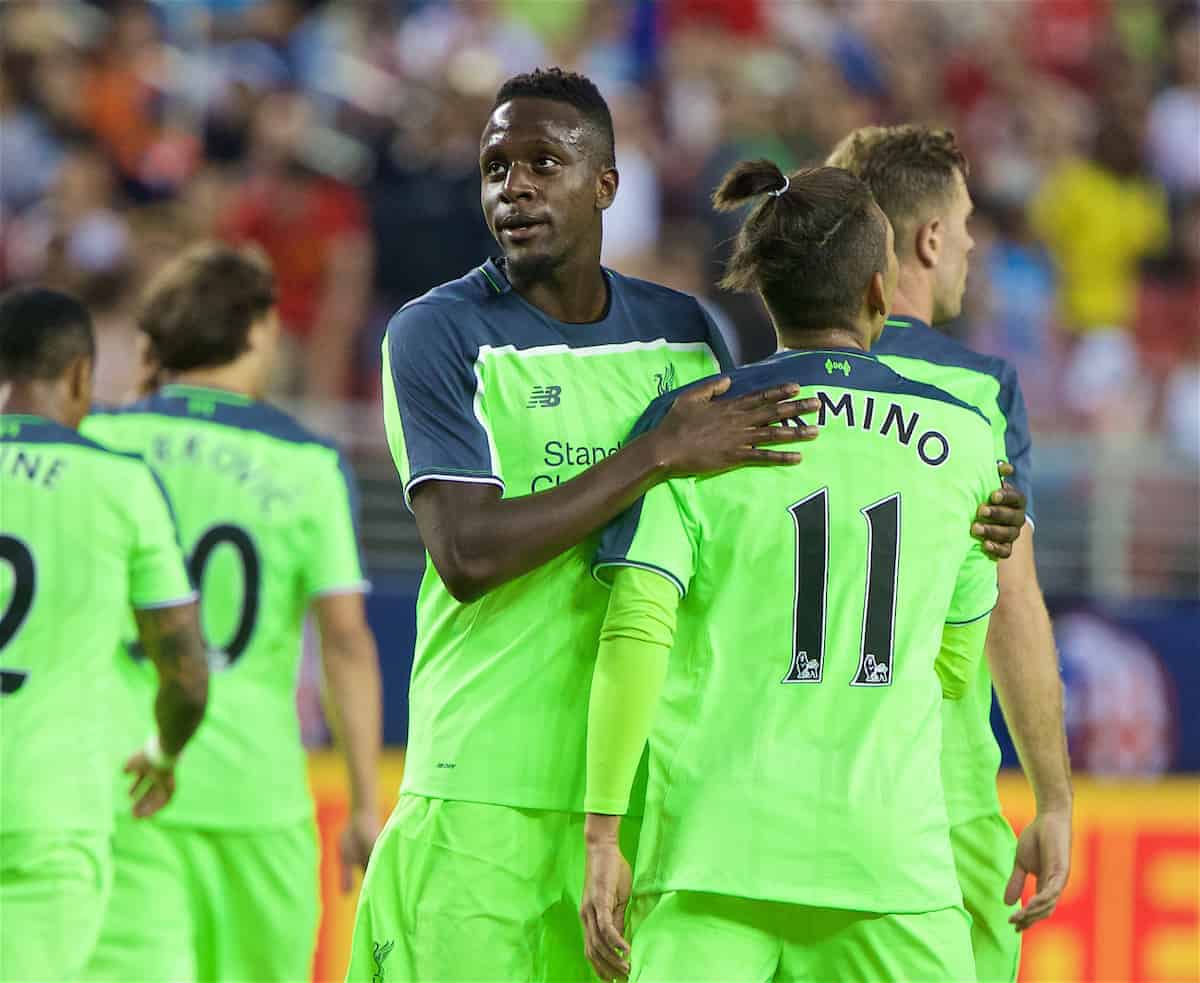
[{"x1": 713, "y1": 161, "x2": 888, "y2": 331}]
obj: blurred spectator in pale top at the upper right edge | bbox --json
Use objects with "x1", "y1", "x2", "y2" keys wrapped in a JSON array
[{"x1": 1148, "y1": 4, "x2": 1200, "y2": 194}]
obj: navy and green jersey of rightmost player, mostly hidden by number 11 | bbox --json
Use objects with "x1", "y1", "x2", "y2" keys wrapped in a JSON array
[{"x1": 871, "y1": 317, "x2": 1033, "y2": 826}]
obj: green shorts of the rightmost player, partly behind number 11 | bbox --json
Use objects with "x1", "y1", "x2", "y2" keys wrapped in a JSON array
[{"x1": 950, "y1": 814, "x2": 1021, "y2": 983}]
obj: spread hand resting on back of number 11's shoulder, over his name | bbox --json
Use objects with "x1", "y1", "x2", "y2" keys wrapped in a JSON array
[{"x1": 650, "y1": 376, "x2": 820, "y2": 478}]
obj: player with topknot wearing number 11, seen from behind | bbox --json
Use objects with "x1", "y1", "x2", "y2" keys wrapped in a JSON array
[{"x1": 582, "y1": 161, "x2": 996, "y2": 983}]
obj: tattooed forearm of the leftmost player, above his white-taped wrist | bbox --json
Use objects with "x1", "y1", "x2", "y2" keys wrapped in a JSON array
[{"x1": 138, "y1": 605, "x2": 209, "y2": 757}]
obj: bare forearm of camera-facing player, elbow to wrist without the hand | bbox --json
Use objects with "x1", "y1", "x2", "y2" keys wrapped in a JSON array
[{"x1": 414, "y1": 432, "x2": 667, "y2": 601}]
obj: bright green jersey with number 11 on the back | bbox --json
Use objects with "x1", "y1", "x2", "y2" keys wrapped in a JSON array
[{"x1": 595, "y1": 349, "x2": 996, "y2": 912}]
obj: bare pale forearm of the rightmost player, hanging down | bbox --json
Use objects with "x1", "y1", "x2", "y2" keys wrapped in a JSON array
[{"x1": 988, "y1": 542, "x2": 1072, "y2": 811}]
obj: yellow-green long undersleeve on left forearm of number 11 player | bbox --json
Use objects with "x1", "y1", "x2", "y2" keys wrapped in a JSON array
[{"x1": 584, "y1": 568, "x2": 679, "y2": 815}]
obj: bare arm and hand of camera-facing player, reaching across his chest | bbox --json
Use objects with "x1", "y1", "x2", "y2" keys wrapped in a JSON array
[{"x1": 412, "y1": 378, "x2": 817, "y2": 603}]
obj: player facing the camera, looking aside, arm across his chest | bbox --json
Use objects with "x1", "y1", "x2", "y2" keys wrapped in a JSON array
[{"x1": 349, "y1": 70, "x2": 815, "y2": 981}]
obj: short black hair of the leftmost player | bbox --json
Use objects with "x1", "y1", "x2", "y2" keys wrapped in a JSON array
[{"x1": 0, "y1": 287, "x2": 96, "y2": 382}]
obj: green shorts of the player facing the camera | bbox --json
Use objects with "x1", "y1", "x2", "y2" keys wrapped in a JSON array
[{"x1": 346, "y1": 795, "x2": 638, "y2": 983}]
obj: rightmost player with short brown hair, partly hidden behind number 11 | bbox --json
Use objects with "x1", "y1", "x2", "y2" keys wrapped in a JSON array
[{"x1": 828, "y1": 125, "x2": 1072, "y2": 981}]
